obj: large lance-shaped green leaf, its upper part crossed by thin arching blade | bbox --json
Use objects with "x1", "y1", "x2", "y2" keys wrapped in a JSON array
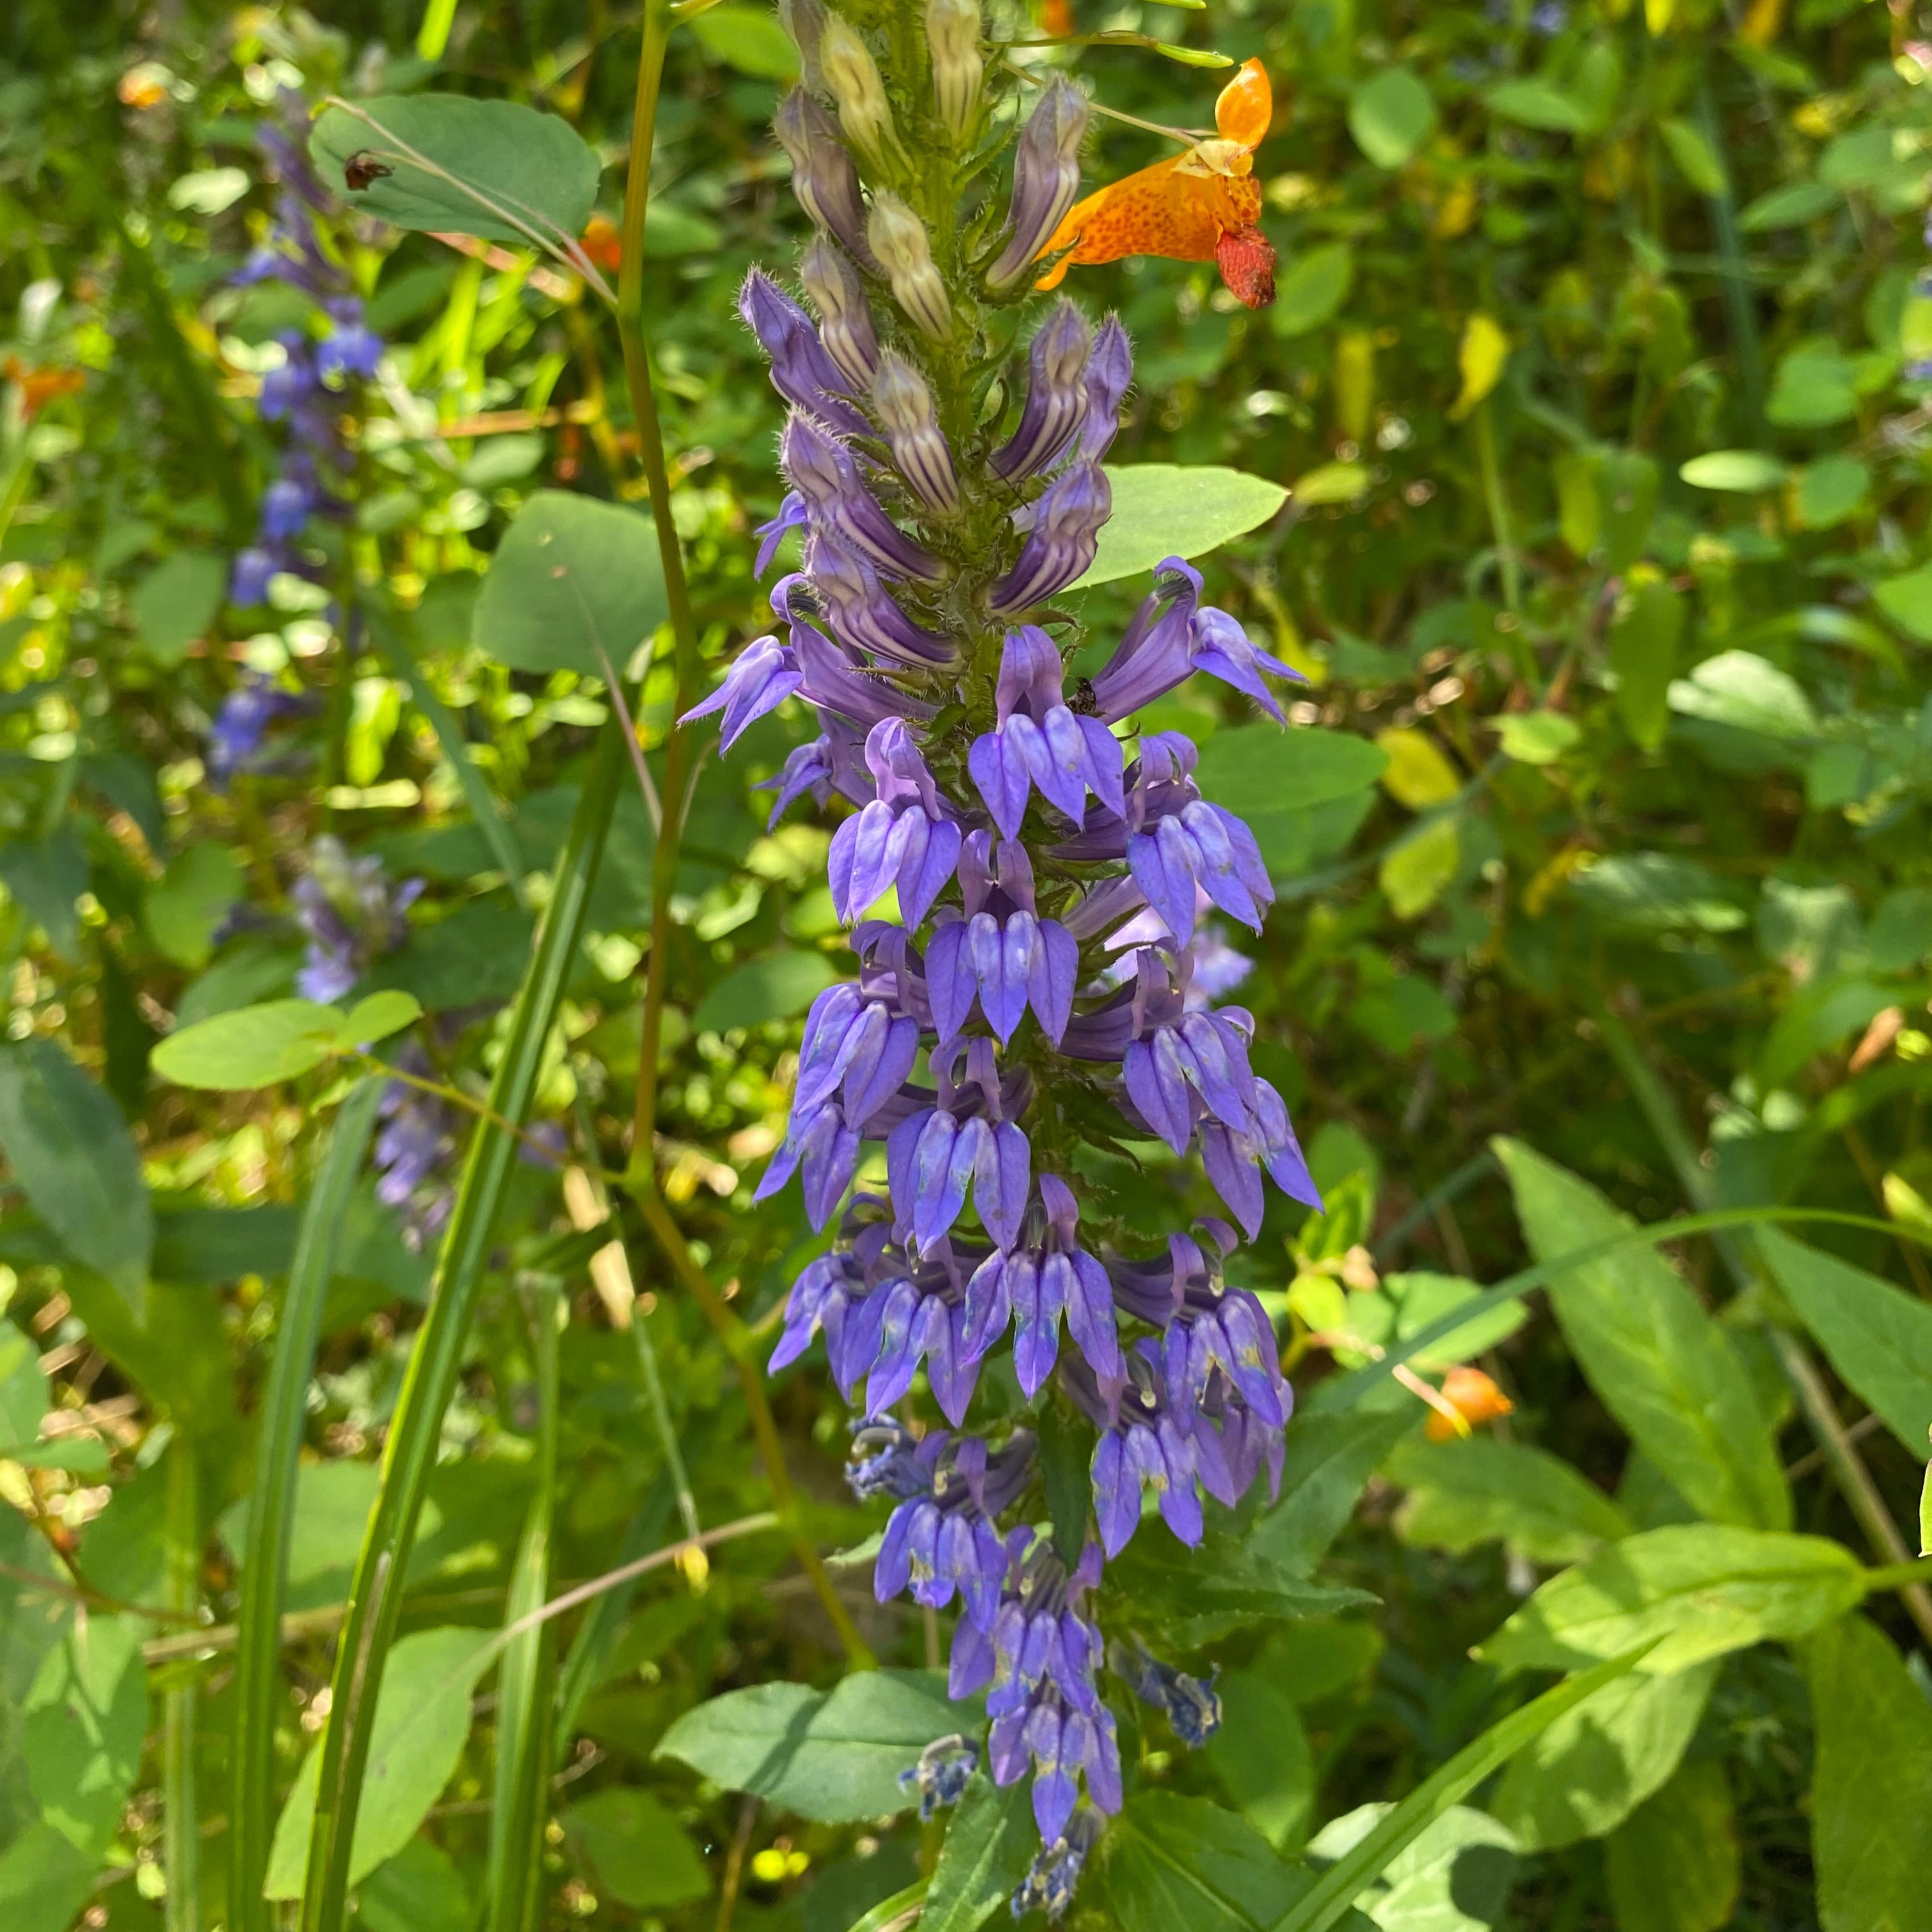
[{"x1": 1494, "y1": 1140, "x2": 1791, "y2": 1530}]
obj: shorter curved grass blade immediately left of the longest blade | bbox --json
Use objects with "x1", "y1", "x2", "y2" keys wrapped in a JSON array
[{"x1": 228, "y1": 1078, "x2": 383, "y2": 1932}]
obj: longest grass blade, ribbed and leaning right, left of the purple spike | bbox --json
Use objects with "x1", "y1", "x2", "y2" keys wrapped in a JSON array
[{"x1": 300, "y1": 713, "x2": 624, "y2": 1932}]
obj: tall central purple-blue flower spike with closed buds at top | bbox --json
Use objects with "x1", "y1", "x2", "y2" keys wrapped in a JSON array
[{"x1": 692, "y1": 0, "x2": 1317, "y2": 1917}]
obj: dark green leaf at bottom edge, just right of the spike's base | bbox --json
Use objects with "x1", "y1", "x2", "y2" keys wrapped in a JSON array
[{"x1": 1092, "y1": 1791, "x2": 1308, "y2": 1932}]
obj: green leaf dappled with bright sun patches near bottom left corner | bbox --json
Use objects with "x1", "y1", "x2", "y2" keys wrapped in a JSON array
[{"x1": 19, "y1": 1613, "x2": 147, "y2": 1857}]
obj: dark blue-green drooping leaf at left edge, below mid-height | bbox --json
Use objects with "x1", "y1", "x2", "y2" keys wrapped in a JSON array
[{"x1": 0, "y1": 1038, "x2": 155, "y2": 1317}]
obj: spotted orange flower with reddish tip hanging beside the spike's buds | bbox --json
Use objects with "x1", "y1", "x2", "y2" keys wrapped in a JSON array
[{"x1": 1038, "y1": 60, "x2": 1275, "y2": 309}]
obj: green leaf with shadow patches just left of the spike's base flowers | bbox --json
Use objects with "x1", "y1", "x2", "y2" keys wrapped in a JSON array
[{"x1": 655, "y1": 1671, "x2": 970, "y2": 1824}]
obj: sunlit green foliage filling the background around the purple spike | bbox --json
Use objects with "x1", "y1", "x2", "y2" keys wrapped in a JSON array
[{"x1": 0, "y1": 0, "x2": 1932, "y2": 1932}]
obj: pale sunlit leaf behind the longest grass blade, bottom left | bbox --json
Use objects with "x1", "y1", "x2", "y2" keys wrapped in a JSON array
[{"x1": 263, "y1": 1629, "x2": 491, "y2": 1899}]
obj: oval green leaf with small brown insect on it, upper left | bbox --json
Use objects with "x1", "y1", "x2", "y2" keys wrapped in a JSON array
[{"x1": 309, "y1": 95, "x2": 597, "y2": 243}]
